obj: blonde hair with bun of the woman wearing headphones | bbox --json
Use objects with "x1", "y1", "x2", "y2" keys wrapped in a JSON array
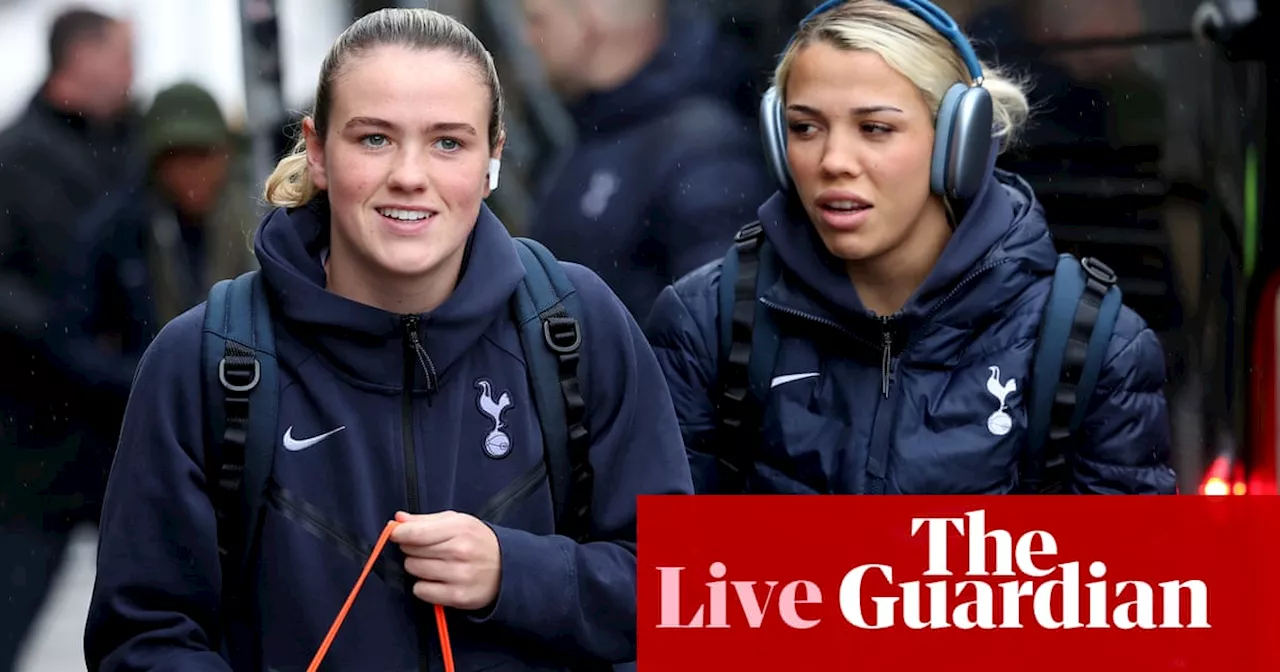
[{"x1": 773, "y1": 0, "x2": 1030, "y2": 148}]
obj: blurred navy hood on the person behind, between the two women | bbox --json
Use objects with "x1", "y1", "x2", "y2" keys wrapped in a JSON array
[{"x1": 568, "y1": 10, "x2": 751, "y2": 136}]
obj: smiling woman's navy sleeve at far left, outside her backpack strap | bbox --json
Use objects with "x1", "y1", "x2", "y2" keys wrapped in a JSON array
[{"x1": 84, "y1": 306, "x2": 230, "y2": 672}]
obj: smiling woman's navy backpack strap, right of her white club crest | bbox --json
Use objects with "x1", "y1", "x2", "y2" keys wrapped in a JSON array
[{"x1": 512, "y1": 238, "x2": 595, "y2": 541}]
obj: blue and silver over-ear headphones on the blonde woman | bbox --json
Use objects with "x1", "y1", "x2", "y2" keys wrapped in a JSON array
[{"x1": 760, "y1": 0, "x2": 995, "y2": 201}]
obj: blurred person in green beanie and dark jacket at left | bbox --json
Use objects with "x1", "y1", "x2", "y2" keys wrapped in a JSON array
[{"x1": 54, "y1": 83, "x2": 256, "y2": 444}]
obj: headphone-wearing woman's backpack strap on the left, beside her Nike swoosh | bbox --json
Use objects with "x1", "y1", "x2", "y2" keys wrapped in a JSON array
[{"x1": 710, "y1": 221, "x2": 777, "y2": 490}]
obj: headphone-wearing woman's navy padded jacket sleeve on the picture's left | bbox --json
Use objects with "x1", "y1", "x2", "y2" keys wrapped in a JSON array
[{"x1": 645, "y1": 261, "x2": 731, "y2": 494}]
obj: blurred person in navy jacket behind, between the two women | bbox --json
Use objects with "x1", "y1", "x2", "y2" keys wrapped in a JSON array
[{"x1": 524, "y1": 0, "x2": 772, "y2": 319}]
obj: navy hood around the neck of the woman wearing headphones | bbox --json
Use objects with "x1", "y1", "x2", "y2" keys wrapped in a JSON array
[{"x1": 759, "y1": 144, "x2": 1057, "y2": 333}]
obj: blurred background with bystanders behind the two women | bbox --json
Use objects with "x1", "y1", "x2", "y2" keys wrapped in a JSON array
[{"x1": 0, "y1": 0, "x2": 1264, "y2": 672}]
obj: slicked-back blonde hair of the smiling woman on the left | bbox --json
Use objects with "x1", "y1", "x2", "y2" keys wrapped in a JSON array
[{"x1": 264, "y1": 9, "x2": 504, "y2": 207}]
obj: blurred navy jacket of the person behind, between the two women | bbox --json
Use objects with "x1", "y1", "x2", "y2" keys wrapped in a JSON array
[{"x1": 530, "y1": 13, "x2": 773, "y2": 319}]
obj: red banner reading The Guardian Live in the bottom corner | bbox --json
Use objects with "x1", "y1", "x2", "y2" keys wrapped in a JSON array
[{"x1": 637, "y1": 495, "x2": 1280, "y2": 672}]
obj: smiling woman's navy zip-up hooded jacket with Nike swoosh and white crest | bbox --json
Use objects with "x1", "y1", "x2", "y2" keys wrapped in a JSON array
[{"x1": 84, "y1": 200, "x2": 691, "y2": 672}]
